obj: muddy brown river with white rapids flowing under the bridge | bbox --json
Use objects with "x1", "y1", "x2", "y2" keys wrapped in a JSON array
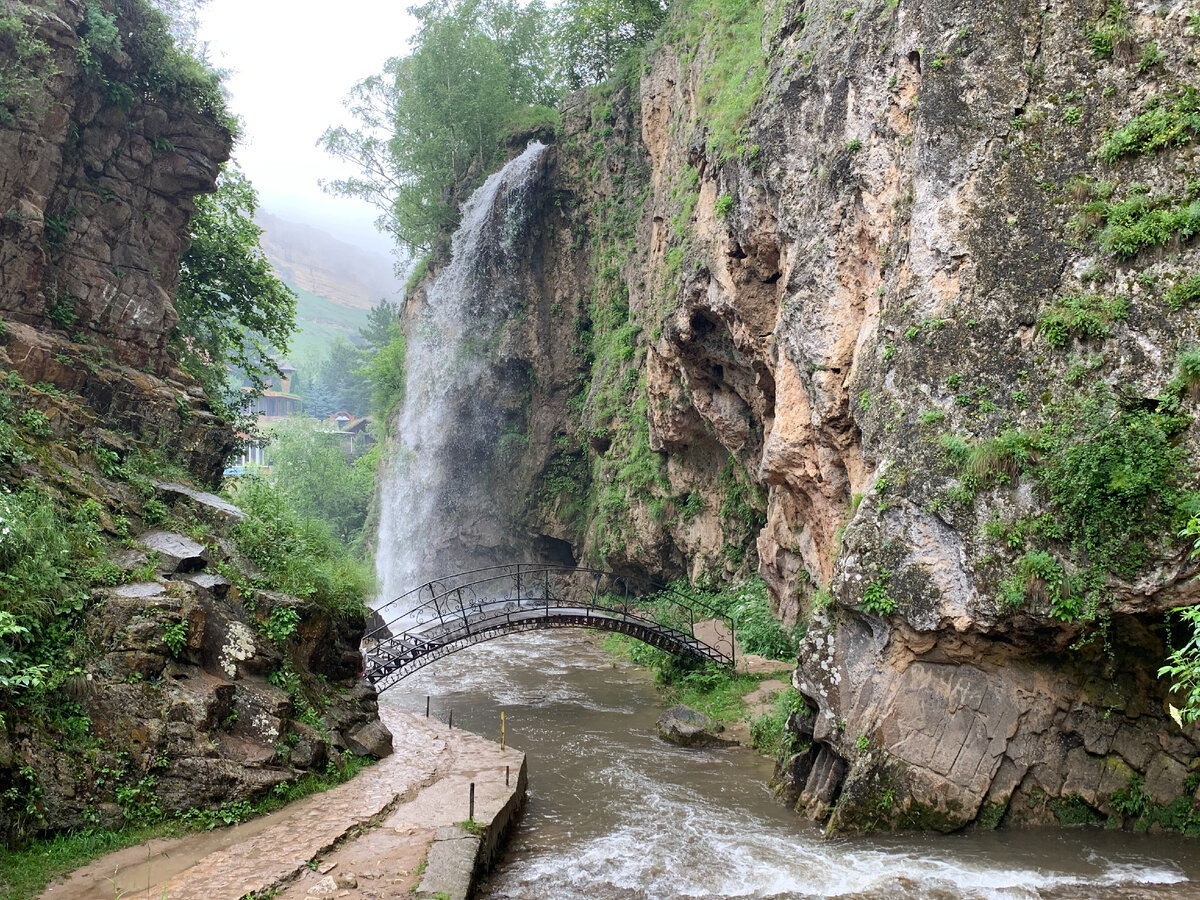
[{"x1": 384, "y1": 632, "x2": 1200, "y2": 900}]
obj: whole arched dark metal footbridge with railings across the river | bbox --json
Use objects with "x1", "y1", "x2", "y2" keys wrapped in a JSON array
[{"x1": 362, "y1": 563, "x2": 736, "y2": 691}]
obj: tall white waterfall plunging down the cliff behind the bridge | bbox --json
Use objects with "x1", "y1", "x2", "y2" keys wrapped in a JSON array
[{"x1": 376, "y1": 142, "x2": 546, "y2": 602}]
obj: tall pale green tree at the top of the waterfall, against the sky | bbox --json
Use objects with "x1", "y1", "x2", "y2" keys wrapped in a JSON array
[{"x1": 322, "y1": 0, "x2": 557, "y2": 250}]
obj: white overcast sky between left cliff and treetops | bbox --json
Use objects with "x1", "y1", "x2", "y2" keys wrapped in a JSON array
[{"x1": 199, "y1": 0, "x2": 414, "y2": 252}]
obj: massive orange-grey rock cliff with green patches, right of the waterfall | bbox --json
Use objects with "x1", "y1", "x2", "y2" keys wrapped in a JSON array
[{"x1": 405, "y1": 0, "x2": 1200, "y2": 830}]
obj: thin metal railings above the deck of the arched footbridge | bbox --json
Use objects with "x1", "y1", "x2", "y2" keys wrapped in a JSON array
[{"x1": 364, "y1": 563, "x2": 736, "y2": 662}]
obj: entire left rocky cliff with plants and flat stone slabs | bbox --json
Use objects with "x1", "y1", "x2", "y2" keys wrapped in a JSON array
[{"x1": 0, "y1": 0, "x2": 388, "y2": 845}]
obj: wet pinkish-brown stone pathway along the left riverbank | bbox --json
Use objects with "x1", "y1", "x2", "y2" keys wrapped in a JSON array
[{"x1": 42, "y1": 704, "x2": 524, "y2": 900}]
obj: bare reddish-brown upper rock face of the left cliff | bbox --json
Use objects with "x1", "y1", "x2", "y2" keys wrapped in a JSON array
[{"x1": 0, "y1": 0, "x2": 233, "y2": 481}]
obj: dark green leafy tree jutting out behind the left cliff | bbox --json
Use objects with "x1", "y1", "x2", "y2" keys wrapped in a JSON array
[{"x1": 175, "y1": 164, "x2": 296, "y2": 414}]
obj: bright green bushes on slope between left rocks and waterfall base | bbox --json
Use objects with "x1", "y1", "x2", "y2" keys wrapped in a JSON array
[{"x1": 230, "y1": 478, "x2": 373, "y2": 616}]
